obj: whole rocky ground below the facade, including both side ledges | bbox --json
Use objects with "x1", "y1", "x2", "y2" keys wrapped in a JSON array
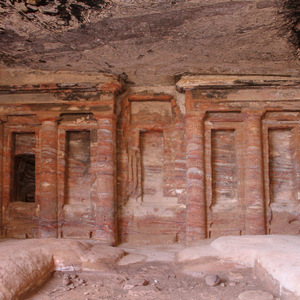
[{"x1": 0, "y1": 235, "x2": 300, "y2": 300}]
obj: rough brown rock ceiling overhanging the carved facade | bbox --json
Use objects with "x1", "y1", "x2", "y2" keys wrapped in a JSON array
[{"x1": 0, "y1": 0, "x2": 300, "y2": 85}]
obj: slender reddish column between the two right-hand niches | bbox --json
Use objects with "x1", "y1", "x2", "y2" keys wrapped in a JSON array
[{"x1": 245, "y1": 111, "x2": 266, "y2": 234}]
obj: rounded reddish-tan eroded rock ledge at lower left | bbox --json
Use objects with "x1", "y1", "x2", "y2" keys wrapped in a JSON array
[{"x1": 0, "y1": 239, "x2": 124, "y2": 300}]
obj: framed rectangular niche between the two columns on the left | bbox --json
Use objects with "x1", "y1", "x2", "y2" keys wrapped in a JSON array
[{"x1": 58, "y1": 119, "x2": 99, "y2": 238}]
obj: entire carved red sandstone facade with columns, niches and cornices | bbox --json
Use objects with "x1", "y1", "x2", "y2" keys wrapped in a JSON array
[{"x1": 0, "y1": 74, "x2": 300, "y2": 243}]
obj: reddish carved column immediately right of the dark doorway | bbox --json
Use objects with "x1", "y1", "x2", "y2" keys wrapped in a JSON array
[{"x1": 39, "y1": 120, "x2": 57, "y2": 237}]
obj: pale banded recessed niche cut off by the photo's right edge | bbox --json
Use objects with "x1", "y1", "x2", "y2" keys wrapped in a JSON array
[{"x1": 268, "y1": 125, "x2": 300, "y2": 234}]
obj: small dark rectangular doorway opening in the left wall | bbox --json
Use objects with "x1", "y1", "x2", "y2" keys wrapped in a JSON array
[{"x1": 13, "y1": 154, "x2": 35, "y2": 202}]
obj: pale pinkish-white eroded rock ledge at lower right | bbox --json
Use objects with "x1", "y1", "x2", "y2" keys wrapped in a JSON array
[{"x1": 178, "y1": 235, "x2": 300, "y2": 299}]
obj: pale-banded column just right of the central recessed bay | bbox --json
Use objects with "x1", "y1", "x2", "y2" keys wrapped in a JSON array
[{"x1": 186, "y1": 113, "x2": 206, "y2": 243}]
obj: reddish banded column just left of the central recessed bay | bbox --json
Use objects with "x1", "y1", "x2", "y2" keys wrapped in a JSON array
[{"x1": 96, "y1": 116, "x2": 117, "y2": 244}]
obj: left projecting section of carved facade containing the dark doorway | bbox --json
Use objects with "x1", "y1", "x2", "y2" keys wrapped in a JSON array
[{"x1": 0, "y1": 73, "x2": 122, "y2": 243}]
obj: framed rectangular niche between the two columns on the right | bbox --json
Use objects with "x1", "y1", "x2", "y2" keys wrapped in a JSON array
[{"x1": 205, "y1": 124, "x2": 245, "y2": 237}]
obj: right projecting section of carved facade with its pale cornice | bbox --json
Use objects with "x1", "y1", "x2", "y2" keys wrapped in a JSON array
[{"x1": 178, "y1": 76, "x2": 300, "y2": 241}]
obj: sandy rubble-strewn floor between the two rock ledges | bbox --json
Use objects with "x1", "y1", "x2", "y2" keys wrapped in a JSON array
[{"x1": 24, "y1": 249, "x2": 274, "y2": 300}]
